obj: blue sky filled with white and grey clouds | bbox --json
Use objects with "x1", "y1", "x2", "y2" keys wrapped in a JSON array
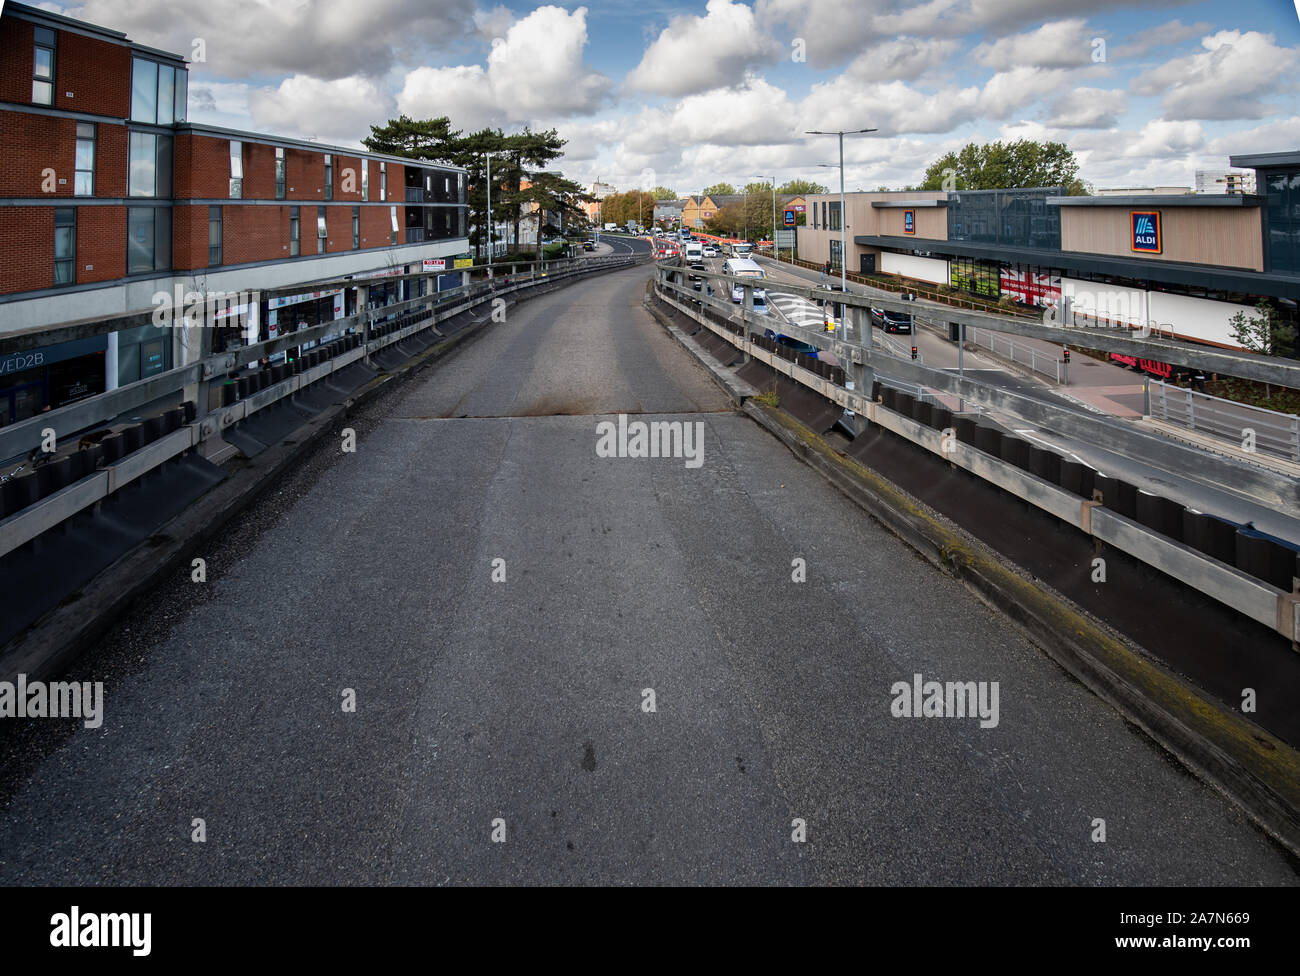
[{"x1": 40, "y1": 0, "x2": 1300, "y2": 194}]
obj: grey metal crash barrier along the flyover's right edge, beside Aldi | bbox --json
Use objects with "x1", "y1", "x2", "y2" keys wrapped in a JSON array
[{"x1": 655, "y1": 265, "x2": 1300, "y2": 643}]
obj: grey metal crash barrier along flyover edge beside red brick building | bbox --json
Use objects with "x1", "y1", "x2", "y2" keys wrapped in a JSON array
[{"x1": 0, "y1": 255, "x2": 644, "y2": 558}]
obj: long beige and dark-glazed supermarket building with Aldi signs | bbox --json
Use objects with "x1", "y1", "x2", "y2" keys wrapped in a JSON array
[{"x1": 797, "y1": 151, "x2": 1300, "y2": 347}]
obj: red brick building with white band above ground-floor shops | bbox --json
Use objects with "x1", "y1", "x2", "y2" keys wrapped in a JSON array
[{"x1": 0, "y1": 3, "x2": 468, "y2": 425}]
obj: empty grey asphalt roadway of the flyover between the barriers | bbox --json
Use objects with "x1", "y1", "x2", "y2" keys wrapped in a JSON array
[{"x1": 0, "y1": 268, "x2": 1296, "y2": 885}]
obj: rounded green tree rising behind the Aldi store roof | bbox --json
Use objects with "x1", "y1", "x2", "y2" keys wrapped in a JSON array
[{"x1": 918, "y1": 139, "x2": 1091, "y2": 196}]
